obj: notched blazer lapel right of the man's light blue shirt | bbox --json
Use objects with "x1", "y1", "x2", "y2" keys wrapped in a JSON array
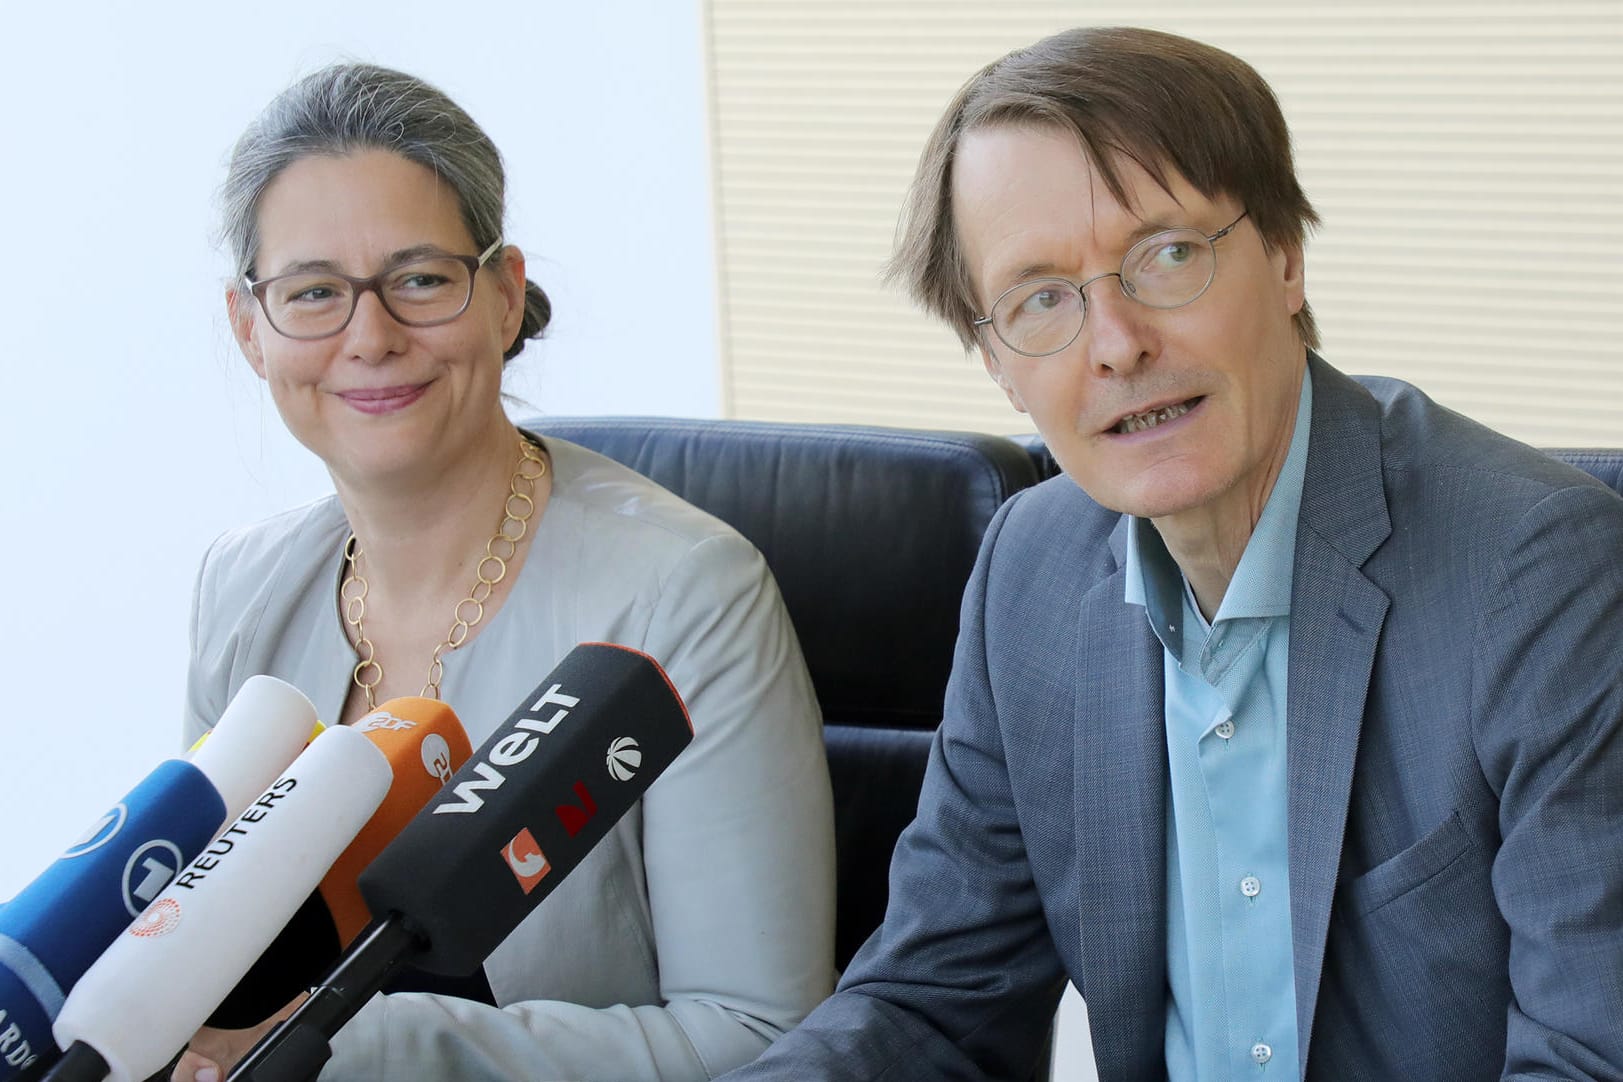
[{"x1": 1285, "y1": 355, "x2": 1391, "y2": 1076}]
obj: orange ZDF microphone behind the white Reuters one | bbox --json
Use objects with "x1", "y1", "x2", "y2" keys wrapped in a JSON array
[{"x1": 208, "y1": 698, "x2": 472, "y2": 1028}]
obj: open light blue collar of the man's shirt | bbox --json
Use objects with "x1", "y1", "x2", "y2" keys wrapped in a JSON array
[{"x1": 1125, "y1": 370, "x2": 1313, "y2": 642}]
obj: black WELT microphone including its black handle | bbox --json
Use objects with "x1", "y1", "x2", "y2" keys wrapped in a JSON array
[{"x1": 230, "y1": 642, "x2": 693, "y2": 1082}]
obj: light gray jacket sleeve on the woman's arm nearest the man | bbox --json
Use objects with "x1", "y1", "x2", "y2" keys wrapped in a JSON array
[{"x1": 321, "y1": 535, "x2": 834, "y2": 1082}]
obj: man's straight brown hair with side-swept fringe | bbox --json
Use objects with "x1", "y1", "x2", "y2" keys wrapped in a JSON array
[{"x1": 888, "y1": 26, "x2": 1318, "y2": 349}]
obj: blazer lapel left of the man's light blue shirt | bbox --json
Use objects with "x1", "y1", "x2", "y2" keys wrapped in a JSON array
[{"x1": 1074, "y1": 519, "x2": 1167, "y2": 1079}]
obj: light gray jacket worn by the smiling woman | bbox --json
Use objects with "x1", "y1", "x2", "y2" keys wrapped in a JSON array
[{"x1": 185, "y1": 440, "x2": 834, "y2": 1082}]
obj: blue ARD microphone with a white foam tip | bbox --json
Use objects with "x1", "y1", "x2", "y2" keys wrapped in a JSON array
[{"x1": 0, "y1": 676, "x2": 315, "y2": 1082}]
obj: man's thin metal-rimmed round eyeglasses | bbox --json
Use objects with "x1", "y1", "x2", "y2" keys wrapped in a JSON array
[{"x1": 974, "y1": 211, "x2": 1248, "y2": 357}]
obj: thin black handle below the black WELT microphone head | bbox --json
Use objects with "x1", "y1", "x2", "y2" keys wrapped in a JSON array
[{"x1": 226, "y1": 913, "x2": 422, "y2": 1082}]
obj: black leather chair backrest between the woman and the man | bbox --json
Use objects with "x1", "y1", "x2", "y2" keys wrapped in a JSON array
[{"x1": 523, "y1": 417, "x2": 1037, "y2": 968}]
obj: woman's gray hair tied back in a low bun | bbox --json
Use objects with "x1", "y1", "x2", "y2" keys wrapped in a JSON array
[{"x1": 219, "y1": 63, "x2": 552, "y2": 360}]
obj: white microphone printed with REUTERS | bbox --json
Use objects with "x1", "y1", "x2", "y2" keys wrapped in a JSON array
[{"x1": 45, "y1": 727, "x2": 391, "y2": 1082}]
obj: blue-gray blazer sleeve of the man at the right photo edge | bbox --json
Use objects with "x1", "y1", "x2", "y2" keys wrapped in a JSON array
[{"x1": 1470, "y1": 485, "x2": 1623, "y2": 1079}]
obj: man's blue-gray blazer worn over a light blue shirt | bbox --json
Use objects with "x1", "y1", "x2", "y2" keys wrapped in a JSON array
[{"x1": 735, "y1": 357, "x2": 1623, "y2": 1082}]
